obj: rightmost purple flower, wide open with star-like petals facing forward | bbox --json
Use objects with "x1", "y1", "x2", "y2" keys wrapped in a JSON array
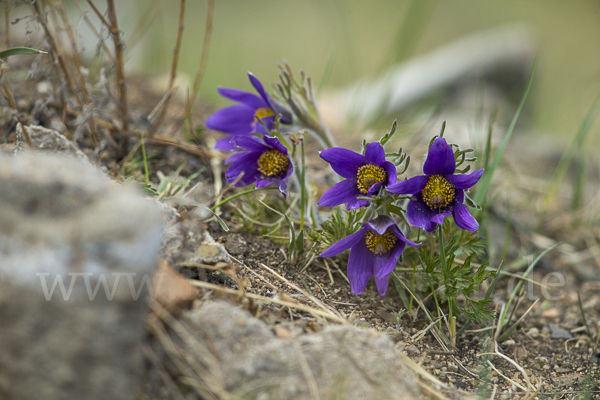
[{"x1": 387, "y1": 137, "x2": 483, "y2": 232}]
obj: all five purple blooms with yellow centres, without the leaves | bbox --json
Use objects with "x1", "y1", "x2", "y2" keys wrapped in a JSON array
[{"x1": 206, "y1": 72, "x2": 483, "y2": 295}]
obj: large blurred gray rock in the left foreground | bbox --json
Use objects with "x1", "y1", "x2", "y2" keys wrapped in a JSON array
[{"x1": 0, "y1": 152, "x2": 161, "y2": 400}]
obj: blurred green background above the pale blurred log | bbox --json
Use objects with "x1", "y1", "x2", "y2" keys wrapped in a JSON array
[{"x1": 126, "y1": 0, "x2": 600, "y2": 143}]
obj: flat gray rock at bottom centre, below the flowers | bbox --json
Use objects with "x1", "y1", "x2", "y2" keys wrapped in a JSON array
[{"x1": 162, "y1": 301, "x2": 420, "y2": 400}]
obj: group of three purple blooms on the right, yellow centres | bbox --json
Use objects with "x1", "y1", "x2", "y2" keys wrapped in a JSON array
[{"x1": 318, "y1": 137, "x2": 483, "y2": 295}]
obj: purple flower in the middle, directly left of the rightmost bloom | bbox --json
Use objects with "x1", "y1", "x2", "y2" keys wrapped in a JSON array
[{"x1": 317, "y1": 142, "x2": 398, "y2": 210}]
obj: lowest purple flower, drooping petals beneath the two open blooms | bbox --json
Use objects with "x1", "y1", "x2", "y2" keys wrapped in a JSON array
[{"x1": 321, "y1": 215, "x2": 421, "y2": 296}]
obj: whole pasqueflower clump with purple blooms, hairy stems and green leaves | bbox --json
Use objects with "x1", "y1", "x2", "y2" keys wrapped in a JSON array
[{"x1": 206, "y1": 64, "x2": 496, "y2": 338}]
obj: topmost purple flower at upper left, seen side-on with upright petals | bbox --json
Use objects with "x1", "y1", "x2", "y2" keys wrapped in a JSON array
[{"x1": 205, "y1": 72, "x2": 291, "y2": 151}]
